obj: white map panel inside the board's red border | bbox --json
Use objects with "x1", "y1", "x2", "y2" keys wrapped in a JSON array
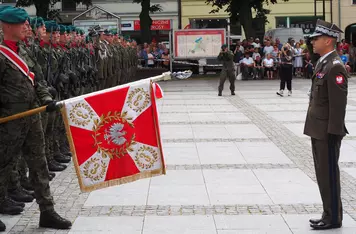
[{"x1": 176, "y1": 30, "x2": 224, "y2": 58}]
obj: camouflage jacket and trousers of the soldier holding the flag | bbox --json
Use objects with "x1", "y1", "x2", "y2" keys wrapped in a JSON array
[{"x1": 0, "y1": 42, "x2": 53, "y2": 211}]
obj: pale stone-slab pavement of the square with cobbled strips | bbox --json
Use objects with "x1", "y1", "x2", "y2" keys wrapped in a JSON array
[{"x1": 0, "y1": 79, "x2": 356, "y2": 234}]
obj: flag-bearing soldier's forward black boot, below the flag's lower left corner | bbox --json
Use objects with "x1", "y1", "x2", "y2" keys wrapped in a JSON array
[{"x1": 40, "y1": 210, "x2": 72, "y2": 229}]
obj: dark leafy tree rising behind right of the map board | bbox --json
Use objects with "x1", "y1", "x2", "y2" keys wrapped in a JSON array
[{"x1": 205, "y1": 0, "x2": 288, "y2": 38}]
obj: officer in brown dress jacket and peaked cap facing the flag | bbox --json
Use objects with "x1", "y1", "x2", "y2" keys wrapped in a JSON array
[{"x1": 304, "y1": 20, "x2": 348, "y2": 230}]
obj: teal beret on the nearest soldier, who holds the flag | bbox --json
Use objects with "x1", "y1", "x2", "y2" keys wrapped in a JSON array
[{"x1": 0, "y1": 6, "x2": 29, "y2": 24}]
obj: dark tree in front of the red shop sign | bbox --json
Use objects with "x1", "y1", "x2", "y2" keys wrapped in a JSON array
[{"x1": 133, "y1": 0, "x2": 162, "y2": 43}]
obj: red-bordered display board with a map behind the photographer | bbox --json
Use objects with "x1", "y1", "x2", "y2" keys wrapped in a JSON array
[{"x1": 173, "y1": 29, "x2": 226, "y2": 59}]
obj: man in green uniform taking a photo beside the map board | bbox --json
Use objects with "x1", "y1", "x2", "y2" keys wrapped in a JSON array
[{"x1": 218, "y1": 45, "x2": 236, "y2": 96}]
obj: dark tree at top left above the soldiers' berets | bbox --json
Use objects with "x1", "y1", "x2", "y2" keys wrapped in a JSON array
[{"x1": 16, "y1": 0, "x2": 92, "y2": 21}]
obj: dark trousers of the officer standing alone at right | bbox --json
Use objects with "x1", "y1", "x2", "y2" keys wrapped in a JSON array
[{"x1": 311, "y1": 136, "x2": 342, "y2": 224}]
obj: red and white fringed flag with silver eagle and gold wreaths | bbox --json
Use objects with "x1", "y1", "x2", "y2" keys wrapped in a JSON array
[{"x1": 62, "y1": 80, "x2": 165, "y2": 192}]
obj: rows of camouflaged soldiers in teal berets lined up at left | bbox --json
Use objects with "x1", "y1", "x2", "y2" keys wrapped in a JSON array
[{"x1": 0, "y1": 6, "x2": 138, "y2": 231}]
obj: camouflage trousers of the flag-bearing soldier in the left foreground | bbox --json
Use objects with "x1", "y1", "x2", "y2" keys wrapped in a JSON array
[{"x1": 0, "y1": 115, "x2": 53, "y2": 211}]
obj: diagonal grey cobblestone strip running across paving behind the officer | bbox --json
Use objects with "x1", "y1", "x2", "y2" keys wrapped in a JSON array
[{"x1": 227, "y1": 91, "x2": 356, "y2": 216}]
